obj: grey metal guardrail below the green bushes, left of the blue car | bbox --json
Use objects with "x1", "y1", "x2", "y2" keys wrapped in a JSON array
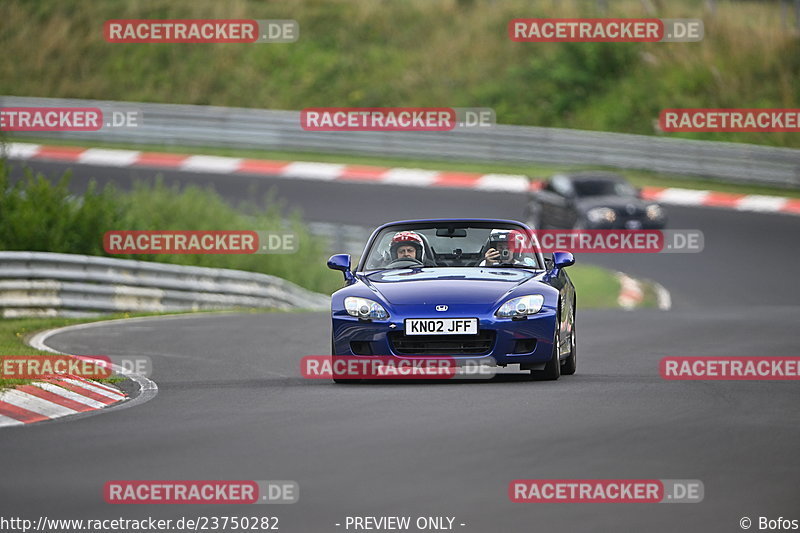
[{"x1": 0, "y1": 252, "x2": 330, "y2": 318}]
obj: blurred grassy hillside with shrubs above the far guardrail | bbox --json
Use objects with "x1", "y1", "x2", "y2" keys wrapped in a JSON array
[{"x1": 0, "y1": 0, "x2": 800, "y2": 147}]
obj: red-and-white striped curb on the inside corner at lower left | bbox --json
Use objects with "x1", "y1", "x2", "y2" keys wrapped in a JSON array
[{"x1": 0, "y1": 376, "x2": 125, "y2": 427}]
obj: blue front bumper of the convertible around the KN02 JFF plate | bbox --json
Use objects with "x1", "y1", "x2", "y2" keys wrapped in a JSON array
[{"x1": 333, "y1": 307, "x2": 556, "y2": 366}]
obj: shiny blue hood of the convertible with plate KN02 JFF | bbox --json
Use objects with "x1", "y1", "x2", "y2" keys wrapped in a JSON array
[{"x1": 360, "y1": 267, "x2": 545, "y2": 305}]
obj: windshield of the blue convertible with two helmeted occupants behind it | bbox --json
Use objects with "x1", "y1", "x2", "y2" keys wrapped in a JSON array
[{"x1": 363, "y1": 223, "x2": 542, "y2": 270}]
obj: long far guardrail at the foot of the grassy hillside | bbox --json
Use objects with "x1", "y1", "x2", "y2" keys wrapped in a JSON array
[{"x1": 0, "y1": 96, "x2": 800, "y2": 187}]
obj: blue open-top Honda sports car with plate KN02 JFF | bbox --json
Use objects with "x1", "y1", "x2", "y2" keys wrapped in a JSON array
[{"x1": 328, "y1": 219, "x2": 577, "y2": 382}]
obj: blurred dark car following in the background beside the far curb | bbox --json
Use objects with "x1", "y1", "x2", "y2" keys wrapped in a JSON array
[{"x1": 525, "y1": 171, "x2": 667, "y2": 229}]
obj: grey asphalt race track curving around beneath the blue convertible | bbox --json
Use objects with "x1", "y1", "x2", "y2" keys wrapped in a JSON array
[{"x1": 0, "y1": 162, "x2": 800, "y2": 532}]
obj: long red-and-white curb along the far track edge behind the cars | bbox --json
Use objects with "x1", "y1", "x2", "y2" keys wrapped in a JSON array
[{"x1": 5, "y1": 142, "x2": 800, "y2": 215}]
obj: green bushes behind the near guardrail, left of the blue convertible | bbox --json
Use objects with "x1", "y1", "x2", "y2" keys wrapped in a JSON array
[{"x1": 0, "y1": 160, "x2": 341, "y2": 294}]
